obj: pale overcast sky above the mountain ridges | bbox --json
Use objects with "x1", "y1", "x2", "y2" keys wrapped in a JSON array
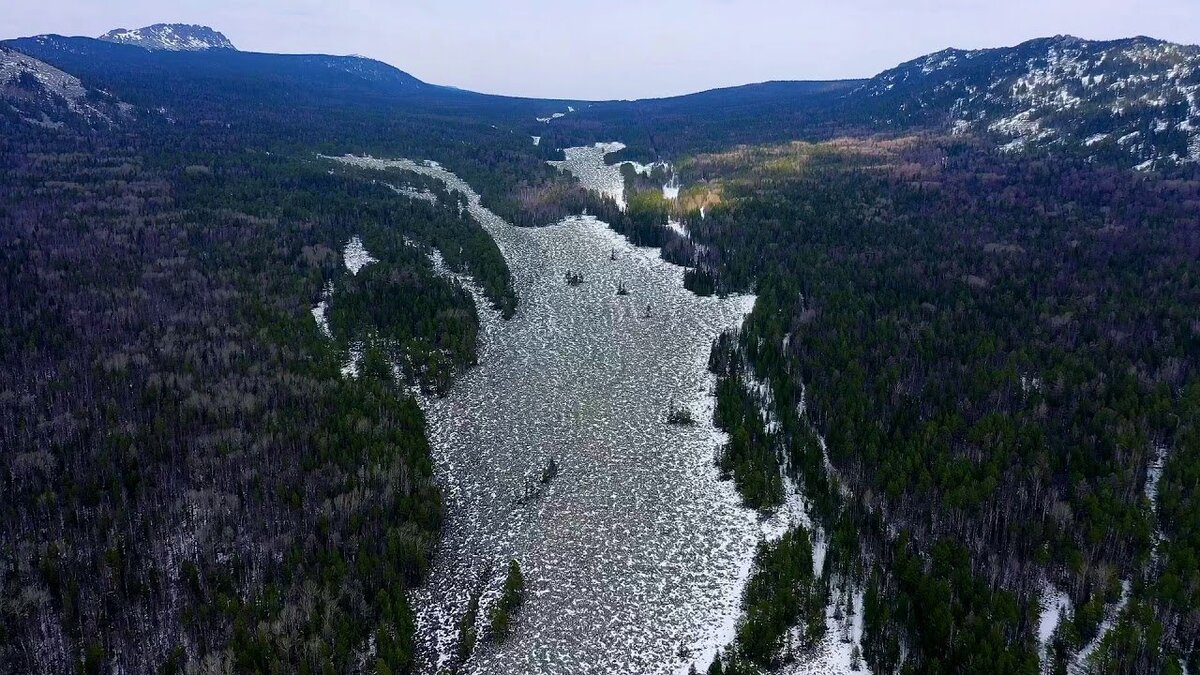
[{"x1": 0, "y1": 0, "x2": 1200, "y2": 100}]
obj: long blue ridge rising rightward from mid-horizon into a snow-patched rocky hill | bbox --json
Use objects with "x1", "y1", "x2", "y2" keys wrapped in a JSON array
[{"x1": 546, "y1": 36, "x2": 1200, "y2": 169}]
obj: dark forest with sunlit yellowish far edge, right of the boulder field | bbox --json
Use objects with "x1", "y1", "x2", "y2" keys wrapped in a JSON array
[{"x1": 680, "y1": 138, "x2": 1200, "y2": 673}]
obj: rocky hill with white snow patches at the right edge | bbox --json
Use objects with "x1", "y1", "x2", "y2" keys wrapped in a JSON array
[{"x1": 852, "y1": 36, "x2": 1200, "y2": 169}]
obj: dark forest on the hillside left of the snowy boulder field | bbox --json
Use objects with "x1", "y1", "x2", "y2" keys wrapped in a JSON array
[{"x1": 0, "y1": 94, "x2": 530, "y2": 673}]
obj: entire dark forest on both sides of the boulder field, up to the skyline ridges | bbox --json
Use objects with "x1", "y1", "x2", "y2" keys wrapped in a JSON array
[{"x1": 0, "y1": 23, "x2": 1200, "y2": 675}]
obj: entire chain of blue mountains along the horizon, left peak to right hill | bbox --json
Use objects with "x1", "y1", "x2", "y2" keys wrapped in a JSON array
[{"x1": 5, "y1": 24, "x2": 1200, "y2": 169}]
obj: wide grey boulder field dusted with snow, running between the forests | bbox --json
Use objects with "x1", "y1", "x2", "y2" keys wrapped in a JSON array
[{"x1": 328, "y1": 153, "x2": 761, "y2": 673}]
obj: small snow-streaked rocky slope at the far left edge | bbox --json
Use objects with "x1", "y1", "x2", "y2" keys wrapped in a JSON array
[{"x1": 0, "y1": 47, "x2": 130, "y2": 127}]
